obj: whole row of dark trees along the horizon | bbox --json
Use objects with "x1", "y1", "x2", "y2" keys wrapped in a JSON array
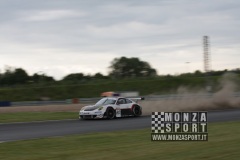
[{"x1": 0, "y1": 57, "x2": 240, "y2": 86}]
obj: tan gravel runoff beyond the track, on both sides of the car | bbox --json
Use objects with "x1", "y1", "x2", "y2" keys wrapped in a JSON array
[{"x1": 0, "y1": 95, "x2": 240, "y2": 115}]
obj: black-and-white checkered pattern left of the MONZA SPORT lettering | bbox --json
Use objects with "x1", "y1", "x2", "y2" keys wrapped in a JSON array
[{"x1": 152, "y1": 112, "x2": 164, "y2": 133}]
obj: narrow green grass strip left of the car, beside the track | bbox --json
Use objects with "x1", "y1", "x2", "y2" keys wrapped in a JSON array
[{"x1": 0, "y1": 112, "x2": 78, "y2": 123}]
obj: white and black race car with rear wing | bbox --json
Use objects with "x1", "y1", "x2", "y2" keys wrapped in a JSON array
[{"x1": 79, "y1": 97, "x2": 144, "y2": 119}]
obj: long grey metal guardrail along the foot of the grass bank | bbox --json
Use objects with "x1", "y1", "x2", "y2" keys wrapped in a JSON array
[{"x1": 5, "y1": 92, "x2": 240, "y2": 106}]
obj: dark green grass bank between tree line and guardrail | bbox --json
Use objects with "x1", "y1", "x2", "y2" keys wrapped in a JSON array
[{"x1": 0, "y1": 77, "x2": 219, "y2": 101}]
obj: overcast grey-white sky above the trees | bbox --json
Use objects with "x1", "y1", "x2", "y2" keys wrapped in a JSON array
[{"x1": 0, "y1": 0, "x2": 240, "y2": 79}]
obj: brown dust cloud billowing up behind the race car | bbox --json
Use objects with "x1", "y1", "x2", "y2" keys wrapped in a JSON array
[{"x1": 140, "y1": 73, "x2": 240, "y2": 115}]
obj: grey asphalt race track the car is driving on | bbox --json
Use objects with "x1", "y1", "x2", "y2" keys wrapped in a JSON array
[{"x1": 0, "y1": 109, "x2": 240, "y2": 143}]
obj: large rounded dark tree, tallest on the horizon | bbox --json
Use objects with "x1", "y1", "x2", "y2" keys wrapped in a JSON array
[{"x1": 109, "y1": 57, "x2": 157, "y2": 78}]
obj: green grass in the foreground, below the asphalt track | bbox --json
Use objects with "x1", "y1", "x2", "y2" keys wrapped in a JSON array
[{"x1": 0, "y1": 121, "x2": 240, "y2": 160}]
